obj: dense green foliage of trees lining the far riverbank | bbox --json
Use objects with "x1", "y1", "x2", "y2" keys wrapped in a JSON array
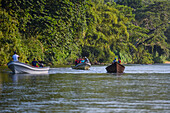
[{"x1": 0, "y1": 0, "x2": 170, "y2": 65}]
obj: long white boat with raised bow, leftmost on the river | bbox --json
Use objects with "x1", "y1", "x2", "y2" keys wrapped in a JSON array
[{"x1": 7, "y1": 61, "x2": 50, "y2": 74}]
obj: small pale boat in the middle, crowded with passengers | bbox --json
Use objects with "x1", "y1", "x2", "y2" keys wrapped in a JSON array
[{"x1": 71, "y1": 62, "x2": 91, "y2": 70}]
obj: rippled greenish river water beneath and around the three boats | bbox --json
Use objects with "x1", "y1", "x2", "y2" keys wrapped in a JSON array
[{"x1": 0, "y1": 64, "x2": 170, "y2": 113}]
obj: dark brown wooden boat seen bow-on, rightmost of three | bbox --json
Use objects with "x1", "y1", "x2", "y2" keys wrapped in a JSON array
[{"x1": 106, "y1": 62, "x2": 125, "y2": 73}]
